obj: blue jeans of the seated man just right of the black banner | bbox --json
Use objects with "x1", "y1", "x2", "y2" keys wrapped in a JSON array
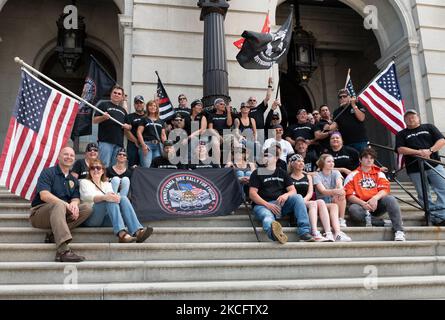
[{"x1": 253, "y1": 194, "x2": 311, "y2": 240}]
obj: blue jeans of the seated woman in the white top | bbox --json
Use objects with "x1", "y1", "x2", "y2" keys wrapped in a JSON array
[{"x1": 83, "y1": 197, "x2": 143, "y2": 235}]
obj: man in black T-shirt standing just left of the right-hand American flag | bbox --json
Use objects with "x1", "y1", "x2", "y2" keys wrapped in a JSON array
[{"x1": 334, "y1": 89, "x2": 368, "y2": 153}]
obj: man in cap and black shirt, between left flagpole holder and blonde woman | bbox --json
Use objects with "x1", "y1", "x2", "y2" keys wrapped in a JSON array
[{"x1": 125, "y1": 95, "x2": 145, "y2": 168}]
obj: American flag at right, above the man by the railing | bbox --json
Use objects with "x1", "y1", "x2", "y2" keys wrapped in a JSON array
[{"x1": 358, "y1": 61, "x2": 406, "y2": 134}]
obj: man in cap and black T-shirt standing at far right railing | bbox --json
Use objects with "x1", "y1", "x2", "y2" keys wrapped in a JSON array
[{"x1": 396, "y1": 109, "x2": 445, "y2": 225}]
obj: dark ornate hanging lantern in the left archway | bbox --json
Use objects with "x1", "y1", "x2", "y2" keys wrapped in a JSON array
[{"x1": 56, "y1": 1, "x2": 86, "y2": 73}]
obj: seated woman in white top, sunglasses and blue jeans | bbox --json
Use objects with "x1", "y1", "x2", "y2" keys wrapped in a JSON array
[{"x1": 80, "y1": 159, "x2": 153, "y2": 243}]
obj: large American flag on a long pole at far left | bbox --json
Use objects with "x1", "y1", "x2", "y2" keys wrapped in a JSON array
[{"x1": 0, "y1": 69, "x2": 79, "y2": 200}]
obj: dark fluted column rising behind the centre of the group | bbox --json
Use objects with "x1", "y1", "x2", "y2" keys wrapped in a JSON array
[{"x1": 198, "y1": 0, "x2": 229, "y2": 107}]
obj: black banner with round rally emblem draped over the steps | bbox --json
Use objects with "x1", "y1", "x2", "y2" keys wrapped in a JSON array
[{"x1": 131, "y1": 168, "x2": 243, "y2": 221}]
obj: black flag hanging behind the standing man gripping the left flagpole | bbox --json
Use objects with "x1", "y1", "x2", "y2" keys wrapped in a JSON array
[{"x1": 71, "y1": 56, "x2": 116, "y2": 138}]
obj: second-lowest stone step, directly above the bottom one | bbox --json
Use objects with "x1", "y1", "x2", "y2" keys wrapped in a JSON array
[{"x1": 0, "y1": 257, "x2": 445, "y2": 285}]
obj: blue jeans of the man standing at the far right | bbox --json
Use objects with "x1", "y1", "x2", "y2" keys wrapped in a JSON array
[{"x1": 409, "y1": 165, "x2": 445, "y2": 223}]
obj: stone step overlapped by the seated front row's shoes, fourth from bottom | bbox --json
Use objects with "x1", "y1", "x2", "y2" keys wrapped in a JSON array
[{"x1": 0, "y1": 227, "x2": 445, "y2": 243}]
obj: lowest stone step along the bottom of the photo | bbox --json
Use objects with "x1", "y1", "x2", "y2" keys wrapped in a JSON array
[{"x1": 0, "y1": 276, "x2": 445, "y2": 300}]
